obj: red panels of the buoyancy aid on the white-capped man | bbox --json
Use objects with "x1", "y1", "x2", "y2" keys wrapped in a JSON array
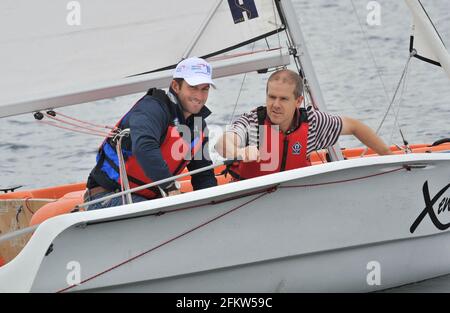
[{"x1": 119, "y1": 125, "x2": 204, "y2": 199}]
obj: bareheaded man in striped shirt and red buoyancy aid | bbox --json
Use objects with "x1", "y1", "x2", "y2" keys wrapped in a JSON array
[{"x1": 215, "y1": 69, "x2": 392, "y2": 180}]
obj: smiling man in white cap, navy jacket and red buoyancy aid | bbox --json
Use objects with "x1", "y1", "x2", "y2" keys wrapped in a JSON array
[{"x1": 85, "y1": 57, "x2": 217, "y2": 210}]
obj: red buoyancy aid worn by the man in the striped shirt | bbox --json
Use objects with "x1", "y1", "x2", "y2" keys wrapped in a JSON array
[{"x1": 229, "y1": 110, "x2": 311, "y2": 180}]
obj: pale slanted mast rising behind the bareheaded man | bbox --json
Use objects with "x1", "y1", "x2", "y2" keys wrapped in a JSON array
[{"x1": 278, "y1": 0, "x2": 344, "y2": 161}]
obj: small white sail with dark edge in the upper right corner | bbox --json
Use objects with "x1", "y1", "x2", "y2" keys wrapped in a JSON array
[{"x1": 406, "y1": 0, "x2": 450, "y2": 77}]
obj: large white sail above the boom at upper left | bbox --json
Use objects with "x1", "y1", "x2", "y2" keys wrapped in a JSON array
[{"x1": 0, "y1": 0, "x2": 283, "y2": 117}]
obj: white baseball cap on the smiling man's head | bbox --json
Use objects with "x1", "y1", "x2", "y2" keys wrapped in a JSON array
[{"x1": 173, "y1": 57, "x2": 216, "y2": 87}]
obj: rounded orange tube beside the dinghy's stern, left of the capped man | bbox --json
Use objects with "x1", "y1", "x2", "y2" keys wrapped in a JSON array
[{"x1": 30, "y1": 190, "x2": 85, "y2": 226}]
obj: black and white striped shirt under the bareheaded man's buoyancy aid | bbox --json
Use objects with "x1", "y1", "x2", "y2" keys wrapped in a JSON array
[{"x1": 227, "y1": 106, "x2": 342, "y2": 155}]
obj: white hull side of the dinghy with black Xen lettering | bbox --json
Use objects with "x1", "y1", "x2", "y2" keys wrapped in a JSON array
[{"x1": 0, "y1": 153, "x2": 450, "y2": 292}]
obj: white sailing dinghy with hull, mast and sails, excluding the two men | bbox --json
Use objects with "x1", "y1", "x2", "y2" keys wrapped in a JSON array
[{"x1": 0, "y1": 0, "x2": 450, "y2": 292}]
